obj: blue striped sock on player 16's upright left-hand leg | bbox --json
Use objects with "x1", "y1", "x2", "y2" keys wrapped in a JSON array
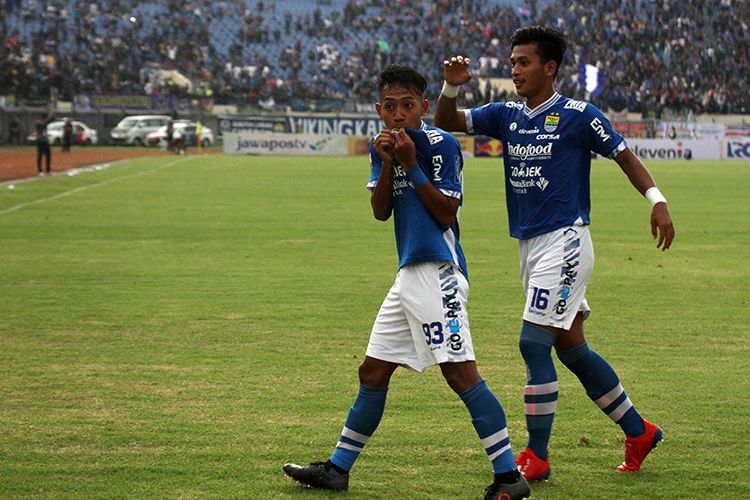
[{"x1": 519, "y1": 323, "x2": 558, "y2": 460}]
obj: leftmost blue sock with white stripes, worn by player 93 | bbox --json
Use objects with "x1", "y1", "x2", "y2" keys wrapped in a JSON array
[{"x1": 330, "y1": 385, "x2": 388, "y2": 472}]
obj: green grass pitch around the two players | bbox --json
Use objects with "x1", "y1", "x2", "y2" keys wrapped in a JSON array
[{"x1": 0, "y1": 156, "x2": 750, "y2": 499}]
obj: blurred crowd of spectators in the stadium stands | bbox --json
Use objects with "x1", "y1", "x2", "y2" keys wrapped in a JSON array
[{"x1": 0, "y1": 0, "x2": 750, "y2": 116}]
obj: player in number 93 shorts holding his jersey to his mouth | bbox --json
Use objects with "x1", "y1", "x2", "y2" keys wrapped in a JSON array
[{"x1": 284, "y1": 65, "x2": 529, "y2": 499}]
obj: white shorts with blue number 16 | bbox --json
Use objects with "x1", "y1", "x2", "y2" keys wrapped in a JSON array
[{"x1": 518, "y1": 226, "x2": 594, "y2": 330}]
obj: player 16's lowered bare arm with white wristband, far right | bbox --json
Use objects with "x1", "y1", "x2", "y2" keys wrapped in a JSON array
[{"x1": 615, "y1": 148, "x2": 675, "y2": 251}]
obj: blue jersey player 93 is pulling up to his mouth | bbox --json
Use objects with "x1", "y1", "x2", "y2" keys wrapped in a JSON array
[{"x1": 367, "y1": 123, "x2": 468, "y2": 278}]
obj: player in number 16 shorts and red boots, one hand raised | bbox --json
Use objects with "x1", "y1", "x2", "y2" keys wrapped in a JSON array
[{"x1": 435, "y1": 26, "x2": 675, "y2": 481}]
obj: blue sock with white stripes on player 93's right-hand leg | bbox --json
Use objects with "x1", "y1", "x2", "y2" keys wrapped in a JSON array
[{"x1": 460, "y1": 380, "x2": 516, "y2": 476}]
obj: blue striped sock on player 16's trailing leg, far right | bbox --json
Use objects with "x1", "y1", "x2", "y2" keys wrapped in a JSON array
[{"x1": 557, "y1": 342, "x2": 646, "y2": 437}]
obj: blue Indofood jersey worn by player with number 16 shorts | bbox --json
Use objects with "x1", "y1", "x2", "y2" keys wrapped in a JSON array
[{"x1": 465, "y1": 92, "x2": 626, "y2": 239}]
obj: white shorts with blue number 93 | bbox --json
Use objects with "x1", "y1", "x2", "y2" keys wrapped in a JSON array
[{"x1": 366, "y1": 262, "x2": 476, "y2": 373}]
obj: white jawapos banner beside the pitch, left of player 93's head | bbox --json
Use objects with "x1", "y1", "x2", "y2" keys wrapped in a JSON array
[{"x1": 224, "y1": 132, "x2": 349, "y2": 156}]
